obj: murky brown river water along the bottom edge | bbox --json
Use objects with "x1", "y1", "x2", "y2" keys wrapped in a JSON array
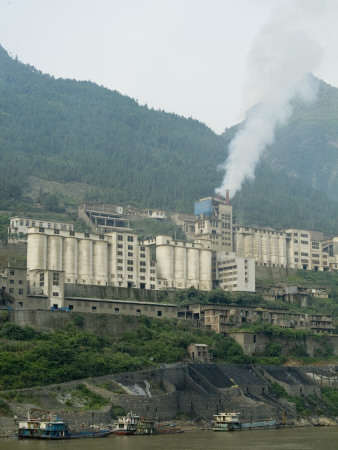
[{"x1": 0, "y1": 427, "x2": 338, "y2": 450}]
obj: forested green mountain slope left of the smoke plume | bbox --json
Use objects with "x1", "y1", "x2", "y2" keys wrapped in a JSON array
[{"x1": 0, "y1": 44, "x2": 225, "y2": 210}]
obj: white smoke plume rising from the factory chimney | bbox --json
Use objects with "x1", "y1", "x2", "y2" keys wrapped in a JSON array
[{"x1": 216, "y1": 1, "x2": 322, "y2": 197}]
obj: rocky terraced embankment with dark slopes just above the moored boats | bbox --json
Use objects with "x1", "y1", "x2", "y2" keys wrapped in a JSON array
[{"x1": 0, "y1": 363, "x2": 338, "y2": 436}]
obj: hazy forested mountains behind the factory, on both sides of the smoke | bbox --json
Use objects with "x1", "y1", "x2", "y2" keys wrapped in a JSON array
[{"x1": 0, "y1": 47, "x2": 338, "y2": 233}]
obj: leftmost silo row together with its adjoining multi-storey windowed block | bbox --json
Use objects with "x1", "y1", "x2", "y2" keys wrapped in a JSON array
[{"x1": 27, "y1": 227, "x2": 156, "y2": 308}]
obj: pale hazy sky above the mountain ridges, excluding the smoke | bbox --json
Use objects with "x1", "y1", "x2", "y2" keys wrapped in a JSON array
[{"x1": 0, "y1": 0, "x2": 338, "y2": 133}]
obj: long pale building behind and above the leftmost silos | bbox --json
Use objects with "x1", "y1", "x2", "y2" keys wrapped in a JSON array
[{"x1": 8, "y1": 216, "x2": 73, "y2": 244}]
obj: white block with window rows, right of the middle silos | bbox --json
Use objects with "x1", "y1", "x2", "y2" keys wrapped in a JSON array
[{"x1": 216, "y1": 252, "x2": 256, "y2": 292}]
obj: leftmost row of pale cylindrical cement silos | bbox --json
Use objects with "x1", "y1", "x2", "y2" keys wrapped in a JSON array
[{"x1": 27, "y1": 233, "x2": 111, "y2": 284}]
